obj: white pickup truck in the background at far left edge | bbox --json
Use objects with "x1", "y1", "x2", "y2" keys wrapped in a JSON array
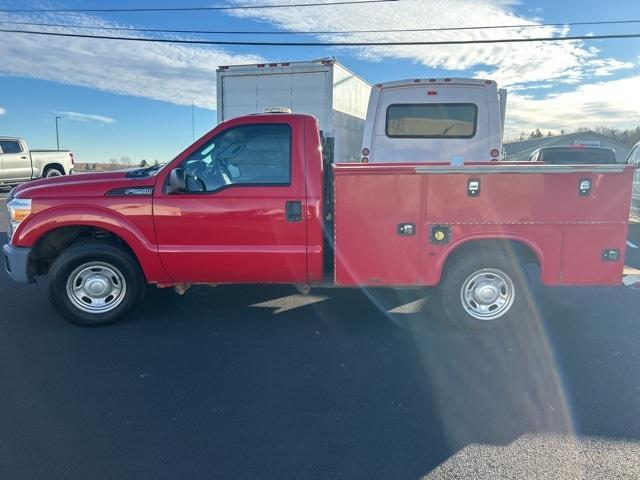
[{"x1": 0, "y1": 137, "x2": 74, "y2": 187}]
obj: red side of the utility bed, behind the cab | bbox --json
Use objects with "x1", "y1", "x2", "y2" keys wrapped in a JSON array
[{"x1": 334, "y1": 164, "x2": 633, "y2": 286}]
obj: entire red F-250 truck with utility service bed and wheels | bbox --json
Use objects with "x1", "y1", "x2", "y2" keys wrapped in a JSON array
[{"x1": 3, "y1": 114, "x2": 640, "y2": 329}]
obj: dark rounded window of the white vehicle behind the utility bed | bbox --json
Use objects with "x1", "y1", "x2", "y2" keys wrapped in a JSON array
[{"x1": 385, "y1": 103, "x2": 478, "y2": 138}]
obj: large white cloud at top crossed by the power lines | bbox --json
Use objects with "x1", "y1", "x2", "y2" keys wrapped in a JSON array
[{"x1": 233, "y1": 0, "x2": 616, "y2": 86}]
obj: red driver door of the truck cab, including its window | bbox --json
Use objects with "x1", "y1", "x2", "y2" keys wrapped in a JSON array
[{"x1": 154, "y1": 119, "x2": 306, "y2": 283}]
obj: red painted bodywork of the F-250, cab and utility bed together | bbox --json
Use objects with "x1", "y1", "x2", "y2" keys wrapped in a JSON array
[{"x1": 14, "y1": 114, "x2": 633, "y2": 286}]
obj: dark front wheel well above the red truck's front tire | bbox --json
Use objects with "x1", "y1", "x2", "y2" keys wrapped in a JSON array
[{"x1": 29, "y1": 225, "x2": 136, "y2": 275}]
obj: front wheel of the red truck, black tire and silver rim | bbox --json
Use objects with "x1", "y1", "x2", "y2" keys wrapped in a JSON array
[{"x1": 49, "y1": 240, "x2": 146, "y2": 327}]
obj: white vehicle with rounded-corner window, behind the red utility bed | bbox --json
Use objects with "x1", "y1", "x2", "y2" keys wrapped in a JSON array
[{"x1": 361, "y1": 78, "x2": 506, "y2": 164}]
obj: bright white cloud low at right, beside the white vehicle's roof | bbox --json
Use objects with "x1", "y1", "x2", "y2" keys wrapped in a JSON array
[{"x1": 505, "y1": 76, "x2": 640, "y2": 138}]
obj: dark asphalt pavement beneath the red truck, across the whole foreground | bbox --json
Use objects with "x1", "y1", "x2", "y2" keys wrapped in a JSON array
[{"x1": 0, "y1": 230, "x2": 640, "y2": 480}]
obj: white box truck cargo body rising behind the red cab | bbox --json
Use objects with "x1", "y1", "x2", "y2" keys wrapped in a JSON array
[{"x1": 216, "y1": 59, "x2": 371, "y2": 163}]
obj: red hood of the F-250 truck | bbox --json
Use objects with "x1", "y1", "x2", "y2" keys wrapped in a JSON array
[{"x1": 13, "y1": 170, "x2": 148, "y2": 199}]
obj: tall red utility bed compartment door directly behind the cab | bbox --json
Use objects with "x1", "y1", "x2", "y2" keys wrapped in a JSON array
[{"x1": 334, "y1": 173, "x2": 426, "y2": 286}]
